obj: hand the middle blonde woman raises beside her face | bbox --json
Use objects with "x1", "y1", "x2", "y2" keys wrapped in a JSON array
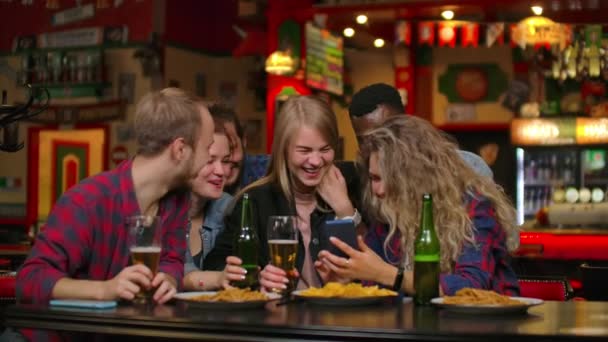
[{"x1": 317, "y1": 165, "x2": 355, "y2": 217}]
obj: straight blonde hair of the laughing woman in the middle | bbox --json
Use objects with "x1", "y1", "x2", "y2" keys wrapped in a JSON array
[{"x1": 235, "y1": 96, "x2": 339, "y2": 204}]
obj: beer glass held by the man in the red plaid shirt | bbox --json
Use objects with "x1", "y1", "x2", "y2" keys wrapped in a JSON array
[{"x1": 127, "y1": 215, "x2": 161, "y2": 303}]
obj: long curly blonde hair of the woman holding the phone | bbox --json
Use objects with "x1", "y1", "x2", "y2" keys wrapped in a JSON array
[{"x1": 359, "y1": 115, "x2": 519, "y2": 272}]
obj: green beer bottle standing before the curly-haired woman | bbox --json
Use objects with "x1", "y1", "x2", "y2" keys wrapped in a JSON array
[{"x1": 414, "y1": 194, "x2": 440, "y2": 305}]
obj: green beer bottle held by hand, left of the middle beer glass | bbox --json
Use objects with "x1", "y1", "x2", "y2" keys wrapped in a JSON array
[{"x1": 234, "y1": 193, "x2": 260, "y2": 288}]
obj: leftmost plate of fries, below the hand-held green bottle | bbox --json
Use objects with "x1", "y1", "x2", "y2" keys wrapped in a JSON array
[{"x1": 173, "y1": 288, "x2": 281, "y2": 309}]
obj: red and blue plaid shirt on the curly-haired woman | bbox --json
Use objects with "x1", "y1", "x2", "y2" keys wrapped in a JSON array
[{"x1": 365, "y1": 196, "x2": 519, "y2": 296}]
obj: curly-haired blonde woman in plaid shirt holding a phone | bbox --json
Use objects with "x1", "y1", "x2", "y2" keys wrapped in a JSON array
[{"x1": 320, "y1": 116, "x2": 519, "y2": 295}]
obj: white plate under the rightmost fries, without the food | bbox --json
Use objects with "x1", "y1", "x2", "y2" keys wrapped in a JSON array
[{"x1": 431, "y1": 297, "x2": 544, "y2": 315}]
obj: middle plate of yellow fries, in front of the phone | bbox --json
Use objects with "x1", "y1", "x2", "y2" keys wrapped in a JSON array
[{"x1": 293, "y1": 282, "x2": 397, "y2": 306}]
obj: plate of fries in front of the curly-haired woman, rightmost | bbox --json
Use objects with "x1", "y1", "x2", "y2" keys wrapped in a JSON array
[{"x1": 431, "y1": 288, "x2": 543, "y2": 314}]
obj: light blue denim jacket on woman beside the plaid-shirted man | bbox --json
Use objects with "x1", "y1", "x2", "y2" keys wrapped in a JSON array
[{"x1": 184, "y1": 193, "x2": 232, "y2": 274}]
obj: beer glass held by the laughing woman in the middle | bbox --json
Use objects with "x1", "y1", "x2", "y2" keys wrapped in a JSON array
[{"x1": 267, "y1": 216, "x2": 298, "y2": 294}]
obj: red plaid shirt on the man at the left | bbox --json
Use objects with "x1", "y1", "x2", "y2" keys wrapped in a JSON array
[{"x1": 17, "y1": 161, "x2": 189, "y2": 303}]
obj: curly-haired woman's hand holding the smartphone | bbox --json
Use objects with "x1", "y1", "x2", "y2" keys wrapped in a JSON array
[{"x1": 317, "y1": 236, "x2": 394, "y2": 282}]
